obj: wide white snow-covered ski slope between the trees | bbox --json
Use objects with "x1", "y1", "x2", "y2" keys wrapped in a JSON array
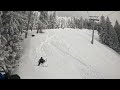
[{"x1": 15, "y1": 28, "x2": 120, "y2": 79}]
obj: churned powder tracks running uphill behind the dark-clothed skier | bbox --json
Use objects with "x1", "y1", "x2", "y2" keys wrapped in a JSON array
[{"x1": 30, "y1": 32, "x2": 54, "y2": 67}]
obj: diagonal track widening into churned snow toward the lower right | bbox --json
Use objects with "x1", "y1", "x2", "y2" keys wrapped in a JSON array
[{"x1": 51, "y1": 39, "x2": 103, "y2": 79}]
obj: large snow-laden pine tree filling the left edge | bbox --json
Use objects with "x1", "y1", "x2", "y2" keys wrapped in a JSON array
[{"x1": 0, "y1": 11, "x2": 26, "y2": 72}]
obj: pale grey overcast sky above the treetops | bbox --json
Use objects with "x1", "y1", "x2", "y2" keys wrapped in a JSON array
[{"x1": 57, "y1": 11, "x2": 120, "y2": 25}]
